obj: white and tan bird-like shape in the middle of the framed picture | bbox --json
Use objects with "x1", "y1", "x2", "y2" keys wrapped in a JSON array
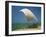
[{"x1": 20, "y1": 8, "x2": 37, "y2": 21}]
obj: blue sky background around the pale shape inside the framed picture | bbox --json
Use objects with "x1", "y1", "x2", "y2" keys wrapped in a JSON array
[{"x1": 12, "y1": 6, "x2": 41, "y2": 23}]
